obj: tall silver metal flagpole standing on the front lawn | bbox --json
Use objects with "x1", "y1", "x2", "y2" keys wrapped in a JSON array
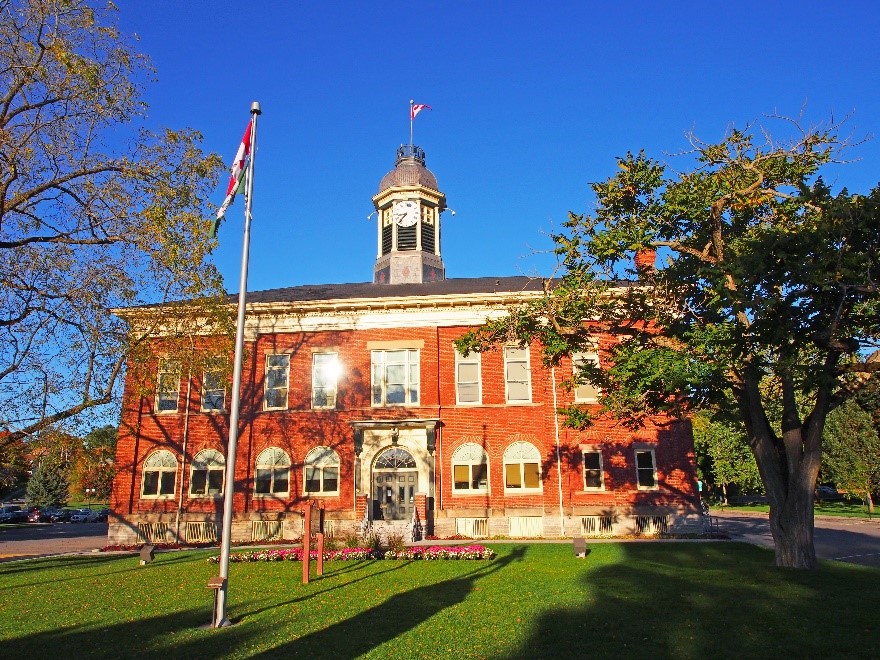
[{"x1": 211, "y1": 101, "x2": 262, "y2": 628}]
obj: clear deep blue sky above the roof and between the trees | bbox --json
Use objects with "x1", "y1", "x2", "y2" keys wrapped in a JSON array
[{"x1": 119, "y1": 0, "x2": 880, "y2": 291}]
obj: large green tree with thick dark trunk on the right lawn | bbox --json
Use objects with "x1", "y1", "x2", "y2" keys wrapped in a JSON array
[{"x1": 459, "y1": 118, "x2": 880, "y2": 568}]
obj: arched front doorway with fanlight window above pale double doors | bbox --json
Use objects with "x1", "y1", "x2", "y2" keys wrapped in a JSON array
[{"x1": 372, "y1": 447, "x2": 419, "y2": 520}]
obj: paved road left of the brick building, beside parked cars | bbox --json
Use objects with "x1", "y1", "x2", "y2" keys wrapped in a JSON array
[{"x1": 0, "y1": 522, "x2": 107, "y2": 561}]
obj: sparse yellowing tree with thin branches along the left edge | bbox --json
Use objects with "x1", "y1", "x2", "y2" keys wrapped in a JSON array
[{"x1": 0, "y1": 0, "x2": 230, "y2": 442}]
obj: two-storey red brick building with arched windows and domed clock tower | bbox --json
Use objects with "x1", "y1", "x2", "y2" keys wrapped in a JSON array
[{"x1": 109, "y1": 146, "x2": 699, "y2": 543}]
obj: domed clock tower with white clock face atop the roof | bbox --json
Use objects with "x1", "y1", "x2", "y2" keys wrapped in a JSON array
[{"x1": 373, "y1": 144, "x2": 446, "y2": 284}]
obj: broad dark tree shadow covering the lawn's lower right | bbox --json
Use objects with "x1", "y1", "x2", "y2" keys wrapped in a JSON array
[{"x1": 509, "y1": 543, "x2": 880, "y2": 658}]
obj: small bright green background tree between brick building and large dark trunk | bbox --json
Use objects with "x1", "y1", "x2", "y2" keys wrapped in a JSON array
[{"x1": 693, "y1": 412, "x2": 763, "y2": 502}]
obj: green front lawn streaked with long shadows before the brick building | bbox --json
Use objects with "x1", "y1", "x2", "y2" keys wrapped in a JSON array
[{"x1": 0, "y1": 543, "x2": 880, "y2": 658}]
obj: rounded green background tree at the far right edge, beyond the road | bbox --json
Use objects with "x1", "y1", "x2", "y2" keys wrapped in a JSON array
[{"x1": 822, "y1": 401, "x2": 880, "y2": 513}]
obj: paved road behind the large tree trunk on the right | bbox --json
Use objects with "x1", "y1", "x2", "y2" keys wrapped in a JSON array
[{"x1": 712, "y1": 511, "x2": 880, "y2": 568}]
